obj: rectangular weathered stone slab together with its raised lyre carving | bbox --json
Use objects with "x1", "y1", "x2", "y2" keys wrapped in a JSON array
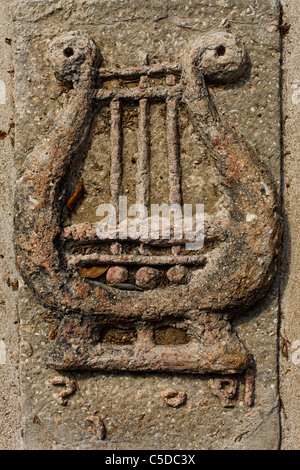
[{"x1": 14, "y1": 0, "x2": 281, "y2": 450}]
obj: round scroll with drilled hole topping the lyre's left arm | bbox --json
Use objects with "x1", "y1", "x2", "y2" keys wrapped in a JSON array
[{"x1": 49, "y1": 31, "x2": 102, "y2": 86}]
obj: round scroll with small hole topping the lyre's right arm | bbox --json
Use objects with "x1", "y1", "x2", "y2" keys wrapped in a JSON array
[{"x1": 184, "y1": 32, "x2": 250, "y2": 83}]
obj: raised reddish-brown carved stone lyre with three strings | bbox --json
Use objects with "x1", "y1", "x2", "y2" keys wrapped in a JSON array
[{"x1": 15, "y1": 32, "x2": 280, "y2": 390}]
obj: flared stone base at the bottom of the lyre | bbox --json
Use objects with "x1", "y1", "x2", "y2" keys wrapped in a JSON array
[{"x1": 46, "y1": 313, "x2": 251, "y2": 374}]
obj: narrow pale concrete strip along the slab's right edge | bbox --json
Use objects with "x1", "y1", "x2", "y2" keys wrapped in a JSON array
[{"x1": 280, "y1": 0, "x2": 300, "y2": 450}]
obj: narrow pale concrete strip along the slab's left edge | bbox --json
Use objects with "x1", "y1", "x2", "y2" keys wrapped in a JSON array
[{"x1": 0, "y1": 2, "x2": 23, "y2": 450}]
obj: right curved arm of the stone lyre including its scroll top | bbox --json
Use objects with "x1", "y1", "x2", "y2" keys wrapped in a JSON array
[{"x1": 183, "y1": 33, "x2": 280, "y2": 313}]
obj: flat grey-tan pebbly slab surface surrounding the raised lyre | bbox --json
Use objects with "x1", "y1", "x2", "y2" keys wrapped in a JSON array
[{"x1": 14, "y1": 0, "x2": 281, "y2": 450}]
